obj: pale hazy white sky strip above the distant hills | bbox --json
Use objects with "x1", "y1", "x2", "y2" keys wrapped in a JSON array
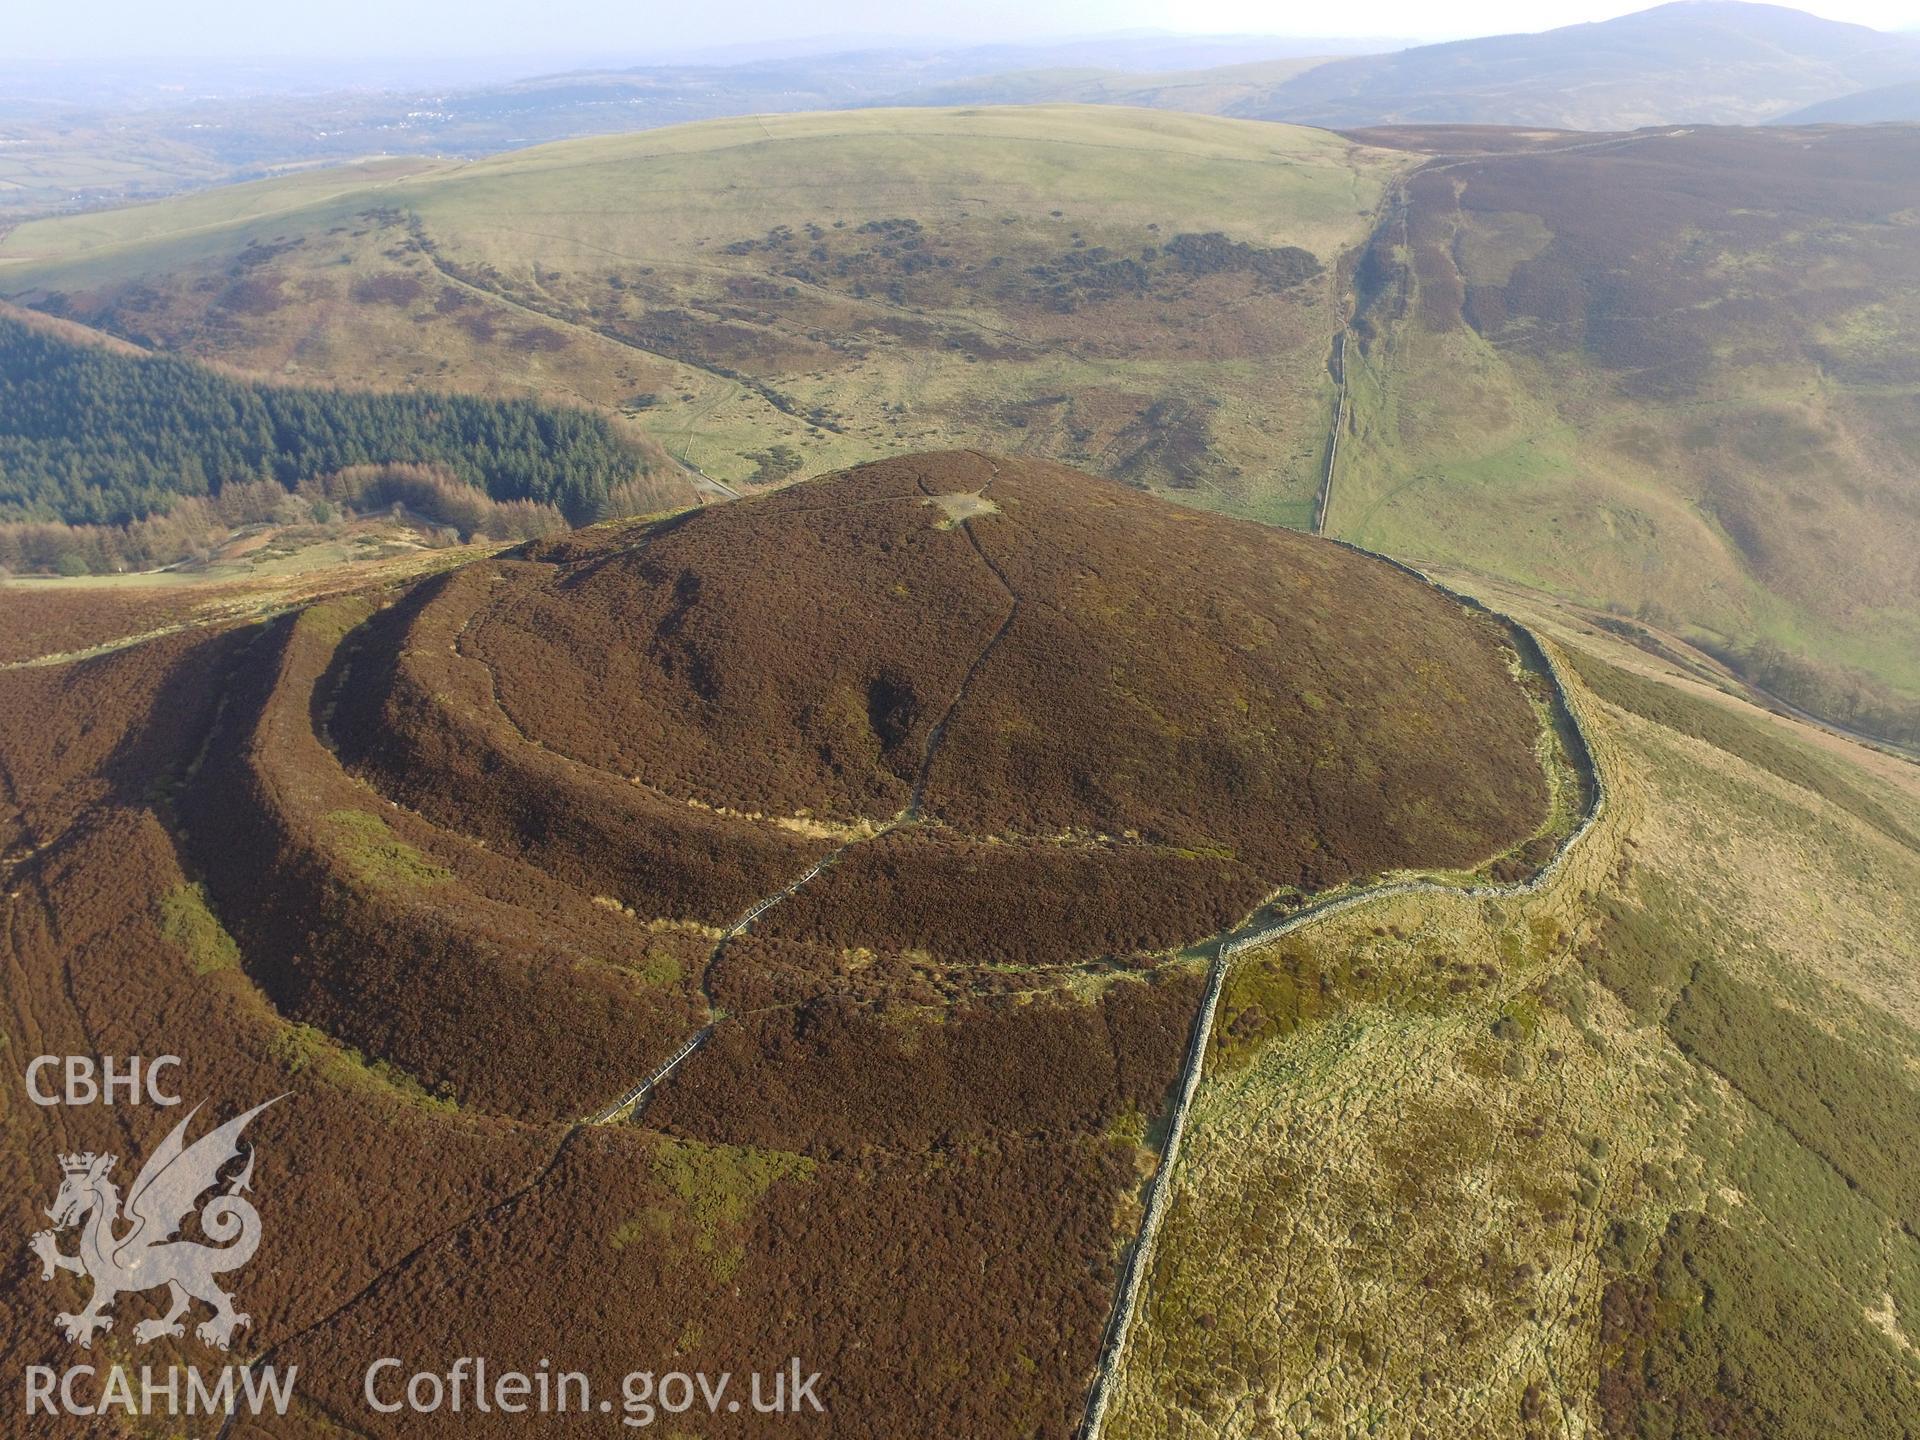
[{"x1": 15, "y1": 0, "x2": 1920, "y2": 61}]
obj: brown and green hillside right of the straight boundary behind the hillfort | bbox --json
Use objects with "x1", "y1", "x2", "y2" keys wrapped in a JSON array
[{"x1": 1329, "y1": 127, "x2": 1920, "y2": 741}]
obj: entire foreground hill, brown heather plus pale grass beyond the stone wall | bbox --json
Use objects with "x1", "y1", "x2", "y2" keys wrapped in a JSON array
[{"x1": 0, "y1": 453, "x2": 1920, "y2": 1440}]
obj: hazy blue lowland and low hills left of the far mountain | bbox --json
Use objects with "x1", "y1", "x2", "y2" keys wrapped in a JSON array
[{"x1": 0, "y1": 35, "x2": 1380, "y2": 227}]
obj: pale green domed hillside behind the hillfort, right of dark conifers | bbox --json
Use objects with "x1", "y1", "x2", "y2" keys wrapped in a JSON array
[{"x1": 0, "y1": 108, "x2": 1411, "y2": 524}]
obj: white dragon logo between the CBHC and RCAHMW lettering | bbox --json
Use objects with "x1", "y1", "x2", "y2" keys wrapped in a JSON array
[{"x1": 31, "y1": 1096, "x2": 286, "y2": 1350}]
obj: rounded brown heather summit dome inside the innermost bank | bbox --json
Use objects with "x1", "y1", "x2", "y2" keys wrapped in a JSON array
[{"x1": 468, "y1": 453, "x2": 1538, "y2": 887}]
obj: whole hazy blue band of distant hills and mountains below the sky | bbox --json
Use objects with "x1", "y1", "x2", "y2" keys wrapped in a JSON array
[{"x1": 0, "y1": 0, "x2": 1920, "y2": 225}]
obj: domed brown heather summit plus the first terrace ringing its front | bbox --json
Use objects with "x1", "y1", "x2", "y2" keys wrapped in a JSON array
[{"x1": 334, "y1": 453, "x2": 1548, "y2": 964}]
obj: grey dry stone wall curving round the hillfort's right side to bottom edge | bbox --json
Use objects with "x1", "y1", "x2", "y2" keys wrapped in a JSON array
[{"x1": 1079, "y1": 564, "x2": 1607, "y2": 1440}]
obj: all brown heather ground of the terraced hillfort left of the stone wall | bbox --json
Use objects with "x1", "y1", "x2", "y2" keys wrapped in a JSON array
[{"x1": 0, "y1": 453, "x2": 1548, "y2": 1440}]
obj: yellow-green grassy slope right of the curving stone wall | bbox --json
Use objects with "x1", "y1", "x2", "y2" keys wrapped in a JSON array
[{"x1": 1102, "y1": 576, "x2": 1920, "y2": 1440}]
